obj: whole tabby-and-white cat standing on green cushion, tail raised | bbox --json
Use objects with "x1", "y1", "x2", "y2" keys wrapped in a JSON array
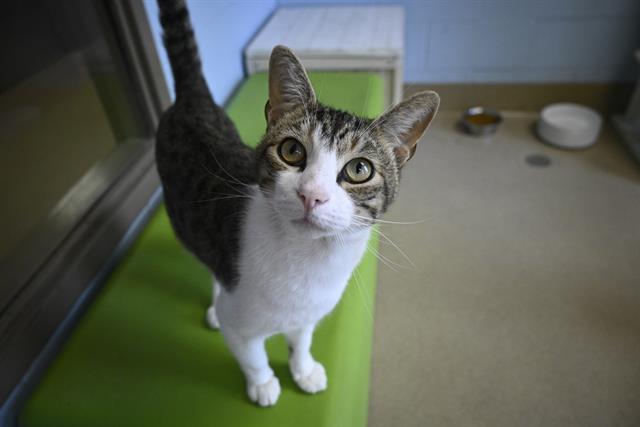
[{"x1": 156, "y1": 0, "x2": 440, "y2": 406}]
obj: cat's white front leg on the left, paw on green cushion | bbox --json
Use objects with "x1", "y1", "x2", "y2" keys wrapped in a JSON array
[{"x1": 221, "y1": 325, "x2": 280, "y2": 406}]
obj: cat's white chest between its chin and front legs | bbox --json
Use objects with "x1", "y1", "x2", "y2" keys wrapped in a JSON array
[{"x1": 217, "y1": 192, "x2": 369, "y2": 335}]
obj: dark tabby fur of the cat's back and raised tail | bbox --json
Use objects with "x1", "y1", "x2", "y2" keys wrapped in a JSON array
[{"x1": 156, "y1": 0, "x2": 257, "y2": 289}]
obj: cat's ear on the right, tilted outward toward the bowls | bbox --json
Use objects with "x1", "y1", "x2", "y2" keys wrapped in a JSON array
[{"x1": 374, "y1": 90, "x2": 440, "y2": 167}]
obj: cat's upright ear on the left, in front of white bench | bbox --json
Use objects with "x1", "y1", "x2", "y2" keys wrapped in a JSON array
[{"x1": 265, "y1": 46, "x2": 316, "y2": 123}]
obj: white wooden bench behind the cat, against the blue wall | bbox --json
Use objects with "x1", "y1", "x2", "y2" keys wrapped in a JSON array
[{"x1": 245, "y1": 6, "x2": 404, "y2": 105}]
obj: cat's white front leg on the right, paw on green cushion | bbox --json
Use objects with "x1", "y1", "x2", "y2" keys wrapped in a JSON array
[{"x1": 285, "y1": 325, "x2": 327, "y2": 393}]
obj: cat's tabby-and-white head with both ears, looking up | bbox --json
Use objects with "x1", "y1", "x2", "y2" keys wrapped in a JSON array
[{"x1": 258, "y1": 46, "x2": 440, "y2": 238}]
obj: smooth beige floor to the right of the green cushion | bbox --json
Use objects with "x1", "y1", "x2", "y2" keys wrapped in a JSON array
[{"x1": 369, "y1": 113, "x2": 640, "y2": 427}]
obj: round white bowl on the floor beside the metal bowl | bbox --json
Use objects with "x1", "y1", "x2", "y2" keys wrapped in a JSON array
[{"x1": 537, "y1": 103, "x2": 602, "y2": 149}]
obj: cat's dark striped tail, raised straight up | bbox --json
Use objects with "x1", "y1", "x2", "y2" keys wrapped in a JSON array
[{"x1": 158, "y1": 0, "x2": 202, "y2": 96}]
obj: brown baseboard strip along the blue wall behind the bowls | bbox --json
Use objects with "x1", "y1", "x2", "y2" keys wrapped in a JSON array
[{"x1": 404, "y1": 83, "x2": 634, "y2": 116}]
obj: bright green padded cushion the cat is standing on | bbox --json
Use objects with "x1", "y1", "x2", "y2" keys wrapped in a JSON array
[{"x1": 19, "y1": 73, "x2": 383, "y2": 427}]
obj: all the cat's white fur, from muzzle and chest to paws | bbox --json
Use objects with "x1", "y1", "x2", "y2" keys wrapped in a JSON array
[{"x1": 207, "y1": 144, "x2": 369, "y2": 406}]
